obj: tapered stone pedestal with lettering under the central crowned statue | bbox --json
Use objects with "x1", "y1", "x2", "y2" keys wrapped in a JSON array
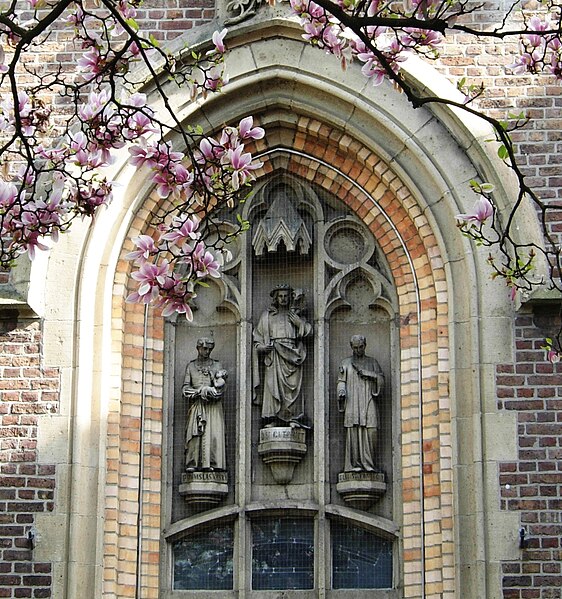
[{"x1": 258, "y1": 426, "x2": 306, "y2": 485}]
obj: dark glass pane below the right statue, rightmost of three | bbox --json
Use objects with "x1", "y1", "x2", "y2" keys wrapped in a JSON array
[{"x1": 332, "y1": 521, "x2": 392, "y2": 589}]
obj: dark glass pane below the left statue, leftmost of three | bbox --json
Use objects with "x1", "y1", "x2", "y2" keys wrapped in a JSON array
[{"x1": 173, "y1": 526, "x2": 234, "y2": 591}]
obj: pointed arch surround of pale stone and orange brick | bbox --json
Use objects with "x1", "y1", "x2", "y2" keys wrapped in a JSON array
[{"x1": 31, "y1": 21, "x2": 524, "y2": 597}]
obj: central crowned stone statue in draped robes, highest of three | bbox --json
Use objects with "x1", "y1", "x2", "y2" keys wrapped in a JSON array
[{"x1": 253, "y1": 284, "x2": 312, "y2": 427}]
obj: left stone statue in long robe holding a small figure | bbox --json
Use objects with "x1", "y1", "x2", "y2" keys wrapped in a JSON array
[{"x1": 182, "y1": 337, "x2": 227, "y2": 472}]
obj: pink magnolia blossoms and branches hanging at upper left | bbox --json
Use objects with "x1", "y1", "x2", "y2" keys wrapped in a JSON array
[{"x1": 0, "y1": 0, "x2": 264, "y2": 318}]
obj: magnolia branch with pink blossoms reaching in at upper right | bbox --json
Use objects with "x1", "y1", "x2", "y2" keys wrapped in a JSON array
[{"x1": 291, "y1": 0, "x2": 562, "y2": 361}]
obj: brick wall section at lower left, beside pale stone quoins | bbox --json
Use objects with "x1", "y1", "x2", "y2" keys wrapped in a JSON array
[{"x1": 0, "y1": 314, "x2": 59, "y2": 598}]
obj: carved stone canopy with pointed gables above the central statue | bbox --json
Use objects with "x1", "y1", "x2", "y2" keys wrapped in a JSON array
[{"x1": 252, "y1": 187, "x2": 312, "y2": 256}]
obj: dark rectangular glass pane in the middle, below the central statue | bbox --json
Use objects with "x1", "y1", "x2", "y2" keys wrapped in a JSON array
[{"x1": 252, "y1": 518, "x2": 314, "y2": 590}]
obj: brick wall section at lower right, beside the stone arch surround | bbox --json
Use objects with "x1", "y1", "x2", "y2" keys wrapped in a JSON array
[{"x1": 497, "y1": 306, "x2": 562, "y2": 599}]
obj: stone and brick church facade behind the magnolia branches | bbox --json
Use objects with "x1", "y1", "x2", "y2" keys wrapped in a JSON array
[{"x1": 0, "y1": 1, "x2": 562, "y2": 599}]
